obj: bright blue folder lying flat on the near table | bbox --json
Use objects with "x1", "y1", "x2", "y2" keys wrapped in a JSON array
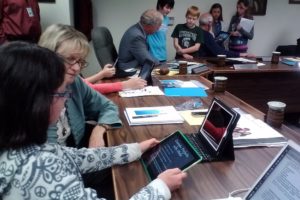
[{"x1": 164, "y1": 87, "x2": 207, "y2": 97}]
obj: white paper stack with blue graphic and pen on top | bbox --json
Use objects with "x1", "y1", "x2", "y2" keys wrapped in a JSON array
[{"x1": 124, "y1": 106, "x2": 184, "y2": 126}]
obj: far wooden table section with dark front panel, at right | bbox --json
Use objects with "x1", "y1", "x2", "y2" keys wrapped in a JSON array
[{"x1": 207, "y1": 59, "x2": 300, "y2": 116}]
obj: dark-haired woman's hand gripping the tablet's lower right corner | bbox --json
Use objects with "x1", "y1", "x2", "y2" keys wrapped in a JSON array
[{"x1": 157, "y1": 168, "x2": 187, "y2": 191}]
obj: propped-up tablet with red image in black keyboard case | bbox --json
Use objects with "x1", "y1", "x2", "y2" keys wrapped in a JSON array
[{"x1": 200, "y1": 100, "x2": 236, "y2": 151}]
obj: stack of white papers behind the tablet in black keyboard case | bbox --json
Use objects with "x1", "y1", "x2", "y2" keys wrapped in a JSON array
[{"x1": 233, "y1": 111, "x2": 287, "y2": 148}]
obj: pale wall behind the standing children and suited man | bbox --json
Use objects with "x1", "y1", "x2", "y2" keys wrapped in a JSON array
[{"x1": 93, "y1": 0, "x2": 300, "y2": 59}]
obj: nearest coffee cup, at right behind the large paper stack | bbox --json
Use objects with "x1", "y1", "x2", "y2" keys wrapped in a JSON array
[{"x1": 266, "y1": 101, "x2": 286, "y2": 128}]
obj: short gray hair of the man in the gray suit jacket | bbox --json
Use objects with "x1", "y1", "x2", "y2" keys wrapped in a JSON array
[{"x1": 140, "y1": 9, "x2": 163, "y2": 26}]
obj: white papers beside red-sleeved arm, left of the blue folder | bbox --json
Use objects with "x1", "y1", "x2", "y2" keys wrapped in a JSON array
[{"x1": 119, "y1": 86, "x2": 164, "y2": 97}]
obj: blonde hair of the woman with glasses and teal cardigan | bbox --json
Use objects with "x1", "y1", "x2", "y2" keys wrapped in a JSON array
[{"x1": 38, "y1": 24, "x2": 90, "y2": 58}]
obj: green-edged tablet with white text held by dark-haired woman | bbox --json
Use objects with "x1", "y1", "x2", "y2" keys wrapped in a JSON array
[{"x1": 141, "y1": 131, "x2": 202, "y2": 180}]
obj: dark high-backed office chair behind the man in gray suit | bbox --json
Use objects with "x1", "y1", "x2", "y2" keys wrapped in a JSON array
[{"x1": 92, "y1": 27, "x2": 118, "y2": 67}]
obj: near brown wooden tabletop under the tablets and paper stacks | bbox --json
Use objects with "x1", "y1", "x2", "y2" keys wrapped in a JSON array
[{"x1": 107, "y1": 75, "x2": 300, "y2": 200}]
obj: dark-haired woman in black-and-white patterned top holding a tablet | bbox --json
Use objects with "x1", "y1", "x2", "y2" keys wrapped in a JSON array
[{"x1": 0, "y1": 42, "x2": 186, "y2": 200}]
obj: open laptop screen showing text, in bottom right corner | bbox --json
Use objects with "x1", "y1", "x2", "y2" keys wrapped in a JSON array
[{"x1": 244, "y1": 141, "x2": 300, "y2": 200}]
